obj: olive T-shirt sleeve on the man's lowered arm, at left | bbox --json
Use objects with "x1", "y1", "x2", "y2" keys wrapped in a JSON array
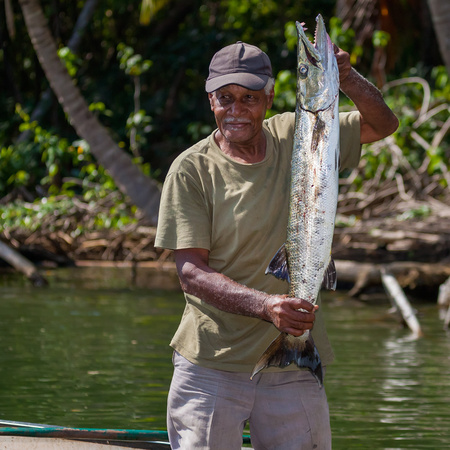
[{"x1": 155, "y1": 171, "x2": 211, "y2": 250}]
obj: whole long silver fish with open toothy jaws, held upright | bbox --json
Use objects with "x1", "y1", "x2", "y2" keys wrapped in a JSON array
[{"x1": 252, "y1": 15, "x2": 339, "y2": 385}]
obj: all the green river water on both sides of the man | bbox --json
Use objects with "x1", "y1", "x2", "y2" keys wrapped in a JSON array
[{"x1": 0, "y1": 268, "x2": 450, "y2": 450}]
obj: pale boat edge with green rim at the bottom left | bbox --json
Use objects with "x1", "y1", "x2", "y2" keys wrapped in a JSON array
[{"x1": 0, "y1": 420, "x2": 250, "y2": 450}]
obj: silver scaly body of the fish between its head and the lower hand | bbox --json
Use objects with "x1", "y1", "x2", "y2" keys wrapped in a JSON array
[{"x1": 286, "y1": 97, "x2": 339, "y2": 303}]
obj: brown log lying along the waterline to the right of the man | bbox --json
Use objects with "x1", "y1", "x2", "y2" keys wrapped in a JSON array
[{"x1": 335, "y1": 260, "x2": 450, "y2": 296}]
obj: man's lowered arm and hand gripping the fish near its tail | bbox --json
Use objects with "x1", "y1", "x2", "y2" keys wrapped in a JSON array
[{"x1": 174, "y1": 248, "x2": 316, "y2": 336}]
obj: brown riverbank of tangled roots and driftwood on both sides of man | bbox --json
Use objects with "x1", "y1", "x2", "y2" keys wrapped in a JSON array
[{"x1": 1, "y1": 217, "x2": 450, "y2": 296}]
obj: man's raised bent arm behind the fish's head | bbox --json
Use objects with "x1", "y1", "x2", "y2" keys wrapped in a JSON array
[{"x1": 335, "y1": 46, "x2": 398, "y2": 144}]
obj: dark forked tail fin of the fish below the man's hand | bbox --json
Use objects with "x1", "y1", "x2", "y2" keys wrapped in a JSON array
[{"x1": 250, "y1": 333, "x2": 323, "y2": 386}]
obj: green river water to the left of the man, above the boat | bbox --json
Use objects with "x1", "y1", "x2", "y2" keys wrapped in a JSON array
[{"x1": 0, "y1": 269, "x2": 183, "y2": 428}]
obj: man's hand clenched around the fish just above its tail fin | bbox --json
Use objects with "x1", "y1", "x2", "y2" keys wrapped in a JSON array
[{"x1": 265, "y1": 295, "x2": 318, "y2": 336}]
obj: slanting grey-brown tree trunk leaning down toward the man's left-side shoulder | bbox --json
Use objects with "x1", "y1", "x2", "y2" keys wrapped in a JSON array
[{"x1": 19, "y1": 0, "x2": 160, "y2": 225}]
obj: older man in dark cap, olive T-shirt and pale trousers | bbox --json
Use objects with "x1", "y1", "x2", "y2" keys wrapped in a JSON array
[{"x1": 156, "y1": 34, "x2": 398, "y2": 450}]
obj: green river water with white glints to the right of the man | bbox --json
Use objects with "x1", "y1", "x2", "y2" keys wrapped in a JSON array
[{"x1": 327, "y1": 297, "x2": 450, "y2": 449}]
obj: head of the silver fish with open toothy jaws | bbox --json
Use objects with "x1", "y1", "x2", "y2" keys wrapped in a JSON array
[{"x1": 296, "y1": 14, "x2": 339, "y2": 112}]
